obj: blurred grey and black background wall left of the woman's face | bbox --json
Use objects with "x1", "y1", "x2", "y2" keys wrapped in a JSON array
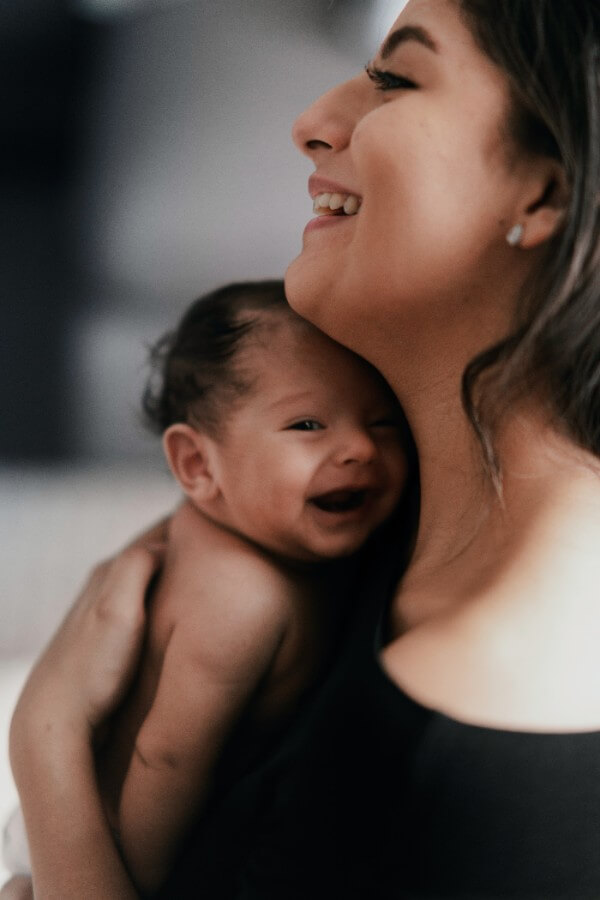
[{"x1": 0, "y1": 0, "x2": 402, "y2": 467}]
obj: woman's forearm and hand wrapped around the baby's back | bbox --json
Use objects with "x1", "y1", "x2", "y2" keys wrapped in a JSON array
[{"x1": 10, "y1": 526, "x2": 164, "y2": 900}]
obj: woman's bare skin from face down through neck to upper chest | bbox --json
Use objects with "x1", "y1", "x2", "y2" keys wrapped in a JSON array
[{"x1": 286, "y1": 0, "x2": 600, "y2": 732}]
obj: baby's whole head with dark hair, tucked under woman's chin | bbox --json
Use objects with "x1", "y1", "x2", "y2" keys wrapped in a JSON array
[{"x1": 144, "y1": 281, "x2": 407, "y2": 562}]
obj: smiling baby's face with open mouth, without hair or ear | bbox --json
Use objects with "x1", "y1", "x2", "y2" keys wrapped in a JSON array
[{"x1": 206, "y1": 322, "x2": 406, "y2": 561}]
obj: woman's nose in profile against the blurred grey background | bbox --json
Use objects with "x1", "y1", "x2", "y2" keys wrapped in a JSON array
[{"x1": 292, "y1": 75, "x2": 367, "y2": 158}]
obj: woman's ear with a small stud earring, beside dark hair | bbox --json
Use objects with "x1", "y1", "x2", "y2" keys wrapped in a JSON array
[{"x1": 519, "y1": 159, "x2": 570, "y2": 250}]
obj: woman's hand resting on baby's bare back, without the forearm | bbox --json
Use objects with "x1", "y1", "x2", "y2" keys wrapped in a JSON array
[{"x1": 10, "y1": 522, "x2": 166, "y2": 768}]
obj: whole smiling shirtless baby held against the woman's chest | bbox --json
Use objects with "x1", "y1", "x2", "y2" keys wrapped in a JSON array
[{"x1": 3, "y1": 281, "x2": 406, "y2": 894}]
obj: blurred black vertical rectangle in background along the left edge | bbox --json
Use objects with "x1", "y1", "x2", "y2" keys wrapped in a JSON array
[{"x1": 0, "y1": 0, "x2": 94, "y2": 460}]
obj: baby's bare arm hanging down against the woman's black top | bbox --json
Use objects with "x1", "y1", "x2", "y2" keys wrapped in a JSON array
[{"x1": 118, "y1": 566, "x2": 286, "y2": 893}]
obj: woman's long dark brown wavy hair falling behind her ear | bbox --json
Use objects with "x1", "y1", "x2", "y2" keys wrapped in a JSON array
[{"x1": 455, "y1": 0, "x2": 600, "y2": 484}]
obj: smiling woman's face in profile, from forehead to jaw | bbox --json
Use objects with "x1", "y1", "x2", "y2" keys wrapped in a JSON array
[{"x1": 286, "y1": 0, "x2": 536, "y2": 364}]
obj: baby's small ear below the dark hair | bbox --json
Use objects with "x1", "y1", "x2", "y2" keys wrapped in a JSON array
[{"x1": 163, "y1": 422, "x2": 219, "y2": 504}]
